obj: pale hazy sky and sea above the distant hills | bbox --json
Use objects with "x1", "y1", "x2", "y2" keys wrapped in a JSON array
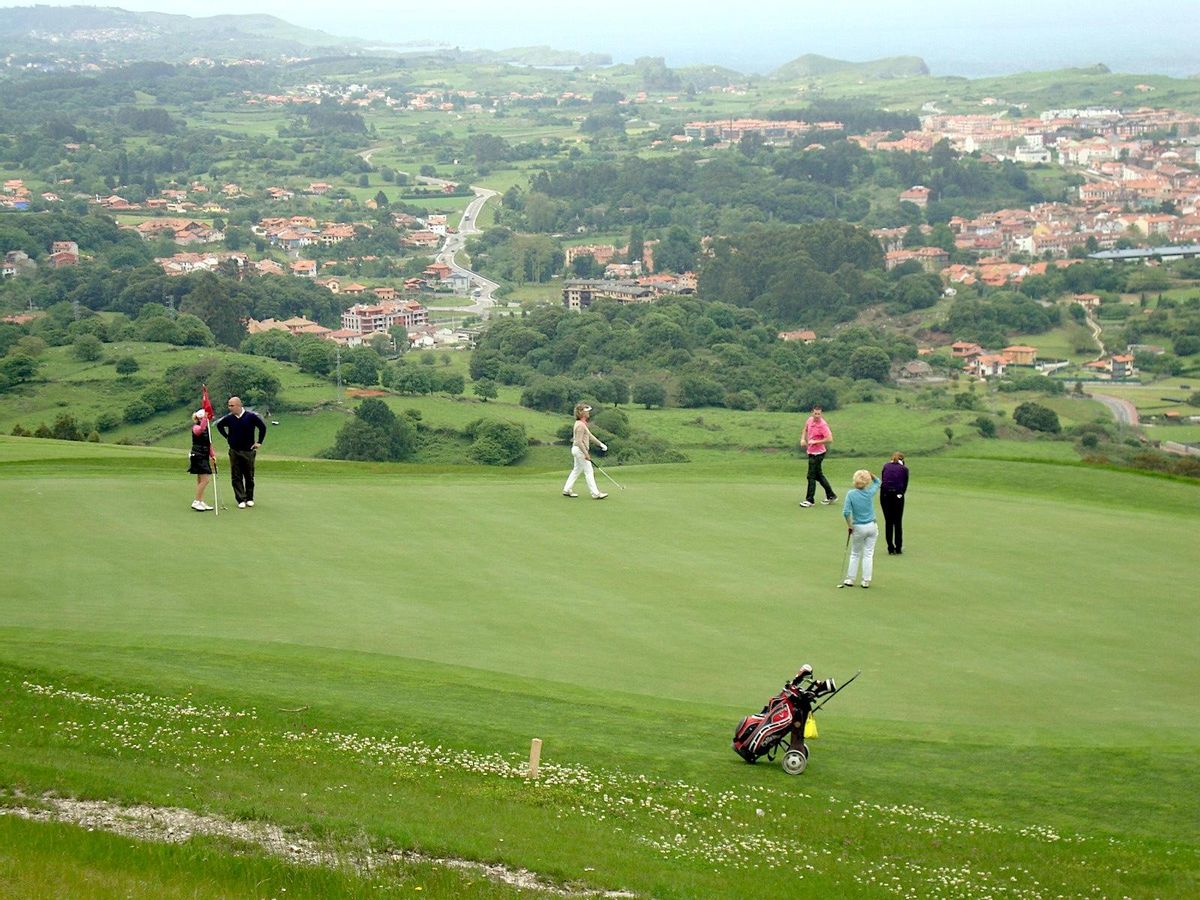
[{"x1": 9, "y1": 0, "x2": 1200, "y2": 76}]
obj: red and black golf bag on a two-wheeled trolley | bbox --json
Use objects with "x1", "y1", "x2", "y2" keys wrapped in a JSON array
[{"x1": 733, "y1": 664, "x2": 859, "y2": 775}]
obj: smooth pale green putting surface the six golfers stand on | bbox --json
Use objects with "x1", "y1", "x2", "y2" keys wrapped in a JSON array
[{"x1": 0, "y1": 440, "x2": 1200, "y2": 746}]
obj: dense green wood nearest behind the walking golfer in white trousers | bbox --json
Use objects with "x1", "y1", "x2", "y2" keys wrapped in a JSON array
[{"x1": 470, "y1": 298, "x2": 917, "y2": 414}]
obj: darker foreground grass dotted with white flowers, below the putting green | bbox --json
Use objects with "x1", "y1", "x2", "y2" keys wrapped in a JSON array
[{"x1": 0, "y1": 640, "x2": 1195, "y2": 896}]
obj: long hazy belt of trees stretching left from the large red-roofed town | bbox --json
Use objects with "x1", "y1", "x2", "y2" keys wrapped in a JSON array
[{"x1": 502, "y1": 128, "x2": 1046, "y2": 243}]
